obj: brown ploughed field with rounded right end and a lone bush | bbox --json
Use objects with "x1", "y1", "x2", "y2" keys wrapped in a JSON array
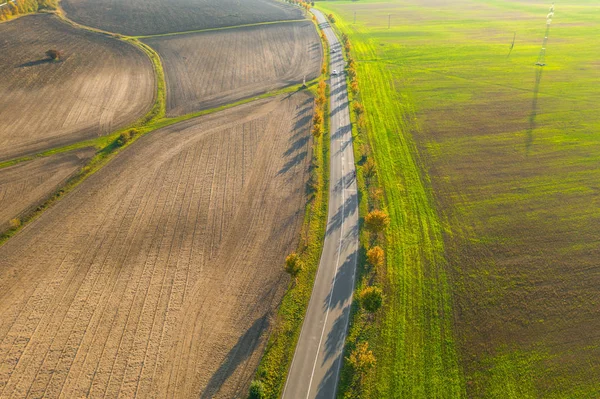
[{"x1": 0, "y1": 15, "x2": 155, "y2": 160}]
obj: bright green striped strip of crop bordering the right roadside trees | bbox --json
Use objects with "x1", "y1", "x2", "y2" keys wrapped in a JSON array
[{"x1": 318, "y1": 4, "x2": 466, "y2": 398}]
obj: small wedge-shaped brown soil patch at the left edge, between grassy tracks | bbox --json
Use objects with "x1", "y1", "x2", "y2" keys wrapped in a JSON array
[{"x1": 0, "y1": 149, "x2": 95, "y2": 232}]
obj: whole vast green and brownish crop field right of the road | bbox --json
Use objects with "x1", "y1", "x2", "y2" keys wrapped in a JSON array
[{"x1": 317, "y1": 0, "x2": 600, "y2": 399}]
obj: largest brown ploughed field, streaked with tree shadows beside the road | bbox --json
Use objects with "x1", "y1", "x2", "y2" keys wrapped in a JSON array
[{"x1": 0, "y1": 94, "x2": 313, "y2": 398}]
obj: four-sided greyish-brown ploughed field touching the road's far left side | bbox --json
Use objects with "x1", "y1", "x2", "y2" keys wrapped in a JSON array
[{"x1": 144, "y1": 21, "x2": 322, "y2": 116}]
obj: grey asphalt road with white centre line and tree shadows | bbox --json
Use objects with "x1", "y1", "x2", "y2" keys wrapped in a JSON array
[{"x1": 282, "y1": 10, "x2": 358, "y2": 399}]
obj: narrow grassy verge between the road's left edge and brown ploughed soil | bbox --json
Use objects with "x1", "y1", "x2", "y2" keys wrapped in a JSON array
[{"x1": 255, "y1": 18, "x2": 330, "y2": 399}]
